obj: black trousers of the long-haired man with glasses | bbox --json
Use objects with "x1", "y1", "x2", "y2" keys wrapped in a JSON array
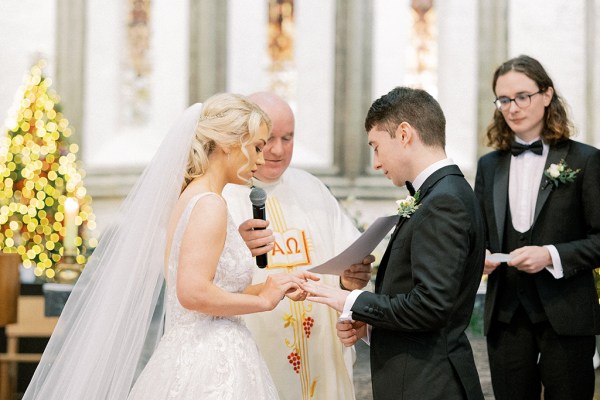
[{"x1": 487, "y1": 306, "x2": 596, "y2": 400}]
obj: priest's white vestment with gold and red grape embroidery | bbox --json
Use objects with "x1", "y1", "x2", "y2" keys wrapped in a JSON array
[{"x1": 223, "y1": 168, "x2": 359, "y2": 400}]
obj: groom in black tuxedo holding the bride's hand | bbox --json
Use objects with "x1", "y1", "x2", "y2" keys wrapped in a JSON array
[{"x1": 305, "y1": 87, "x2": 485, "y2": 400}]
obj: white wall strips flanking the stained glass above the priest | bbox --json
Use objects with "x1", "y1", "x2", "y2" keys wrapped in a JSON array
[{"x1": 227, "y1": 0, "x2": 335, "y2": 168}]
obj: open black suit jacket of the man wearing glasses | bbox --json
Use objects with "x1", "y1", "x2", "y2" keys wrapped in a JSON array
[{"x1": 475, "y1": 140, "x2": 600, "y2": 335}]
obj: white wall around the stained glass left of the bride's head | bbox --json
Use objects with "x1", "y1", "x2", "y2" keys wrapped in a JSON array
[{"x1": 81, "y1": 0, "x2": 188, "y2": 169}]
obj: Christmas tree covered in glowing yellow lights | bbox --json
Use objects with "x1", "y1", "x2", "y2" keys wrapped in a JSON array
[{"x1": 0, "y1": 61, "x2": 96, "y2": 281}]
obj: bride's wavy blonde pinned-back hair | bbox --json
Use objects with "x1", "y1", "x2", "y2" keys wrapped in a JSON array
[{"x1": 181, "y1": 93, "x2": 272, "y2": 191}]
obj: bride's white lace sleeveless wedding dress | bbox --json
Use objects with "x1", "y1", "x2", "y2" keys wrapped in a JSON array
[{"x1": 128, "y1": 193, "x2": 278, "y2": 400}]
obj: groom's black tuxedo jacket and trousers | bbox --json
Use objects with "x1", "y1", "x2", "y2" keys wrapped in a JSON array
[{"x1": 352, "y1": 165, "x2": 485, "y2": 400}]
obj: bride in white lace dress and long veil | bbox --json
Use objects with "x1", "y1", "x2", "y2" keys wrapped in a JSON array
[{"x1": 23, "y1": 94, "x2": 318, "y2": 400}]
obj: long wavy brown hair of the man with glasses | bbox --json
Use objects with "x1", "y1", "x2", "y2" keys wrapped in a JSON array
[{"x1": 486, "y1": 55, "x2": 573, "y2": 150}]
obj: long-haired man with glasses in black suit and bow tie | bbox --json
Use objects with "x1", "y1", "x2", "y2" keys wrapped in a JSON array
[{"x1": 475, "y1": 56, "x2": 600, "y2": 400}]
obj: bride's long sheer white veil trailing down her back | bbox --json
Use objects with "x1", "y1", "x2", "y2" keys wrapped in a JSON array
[{"x1": 23, "y1": 104, "x2": 202, "y2": 400}]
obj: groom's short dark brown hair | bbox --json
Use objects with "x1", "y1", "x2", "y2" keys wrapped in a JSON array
[{"x1": 365, "y1": 87, "x2": 446, "y2": 148}]
